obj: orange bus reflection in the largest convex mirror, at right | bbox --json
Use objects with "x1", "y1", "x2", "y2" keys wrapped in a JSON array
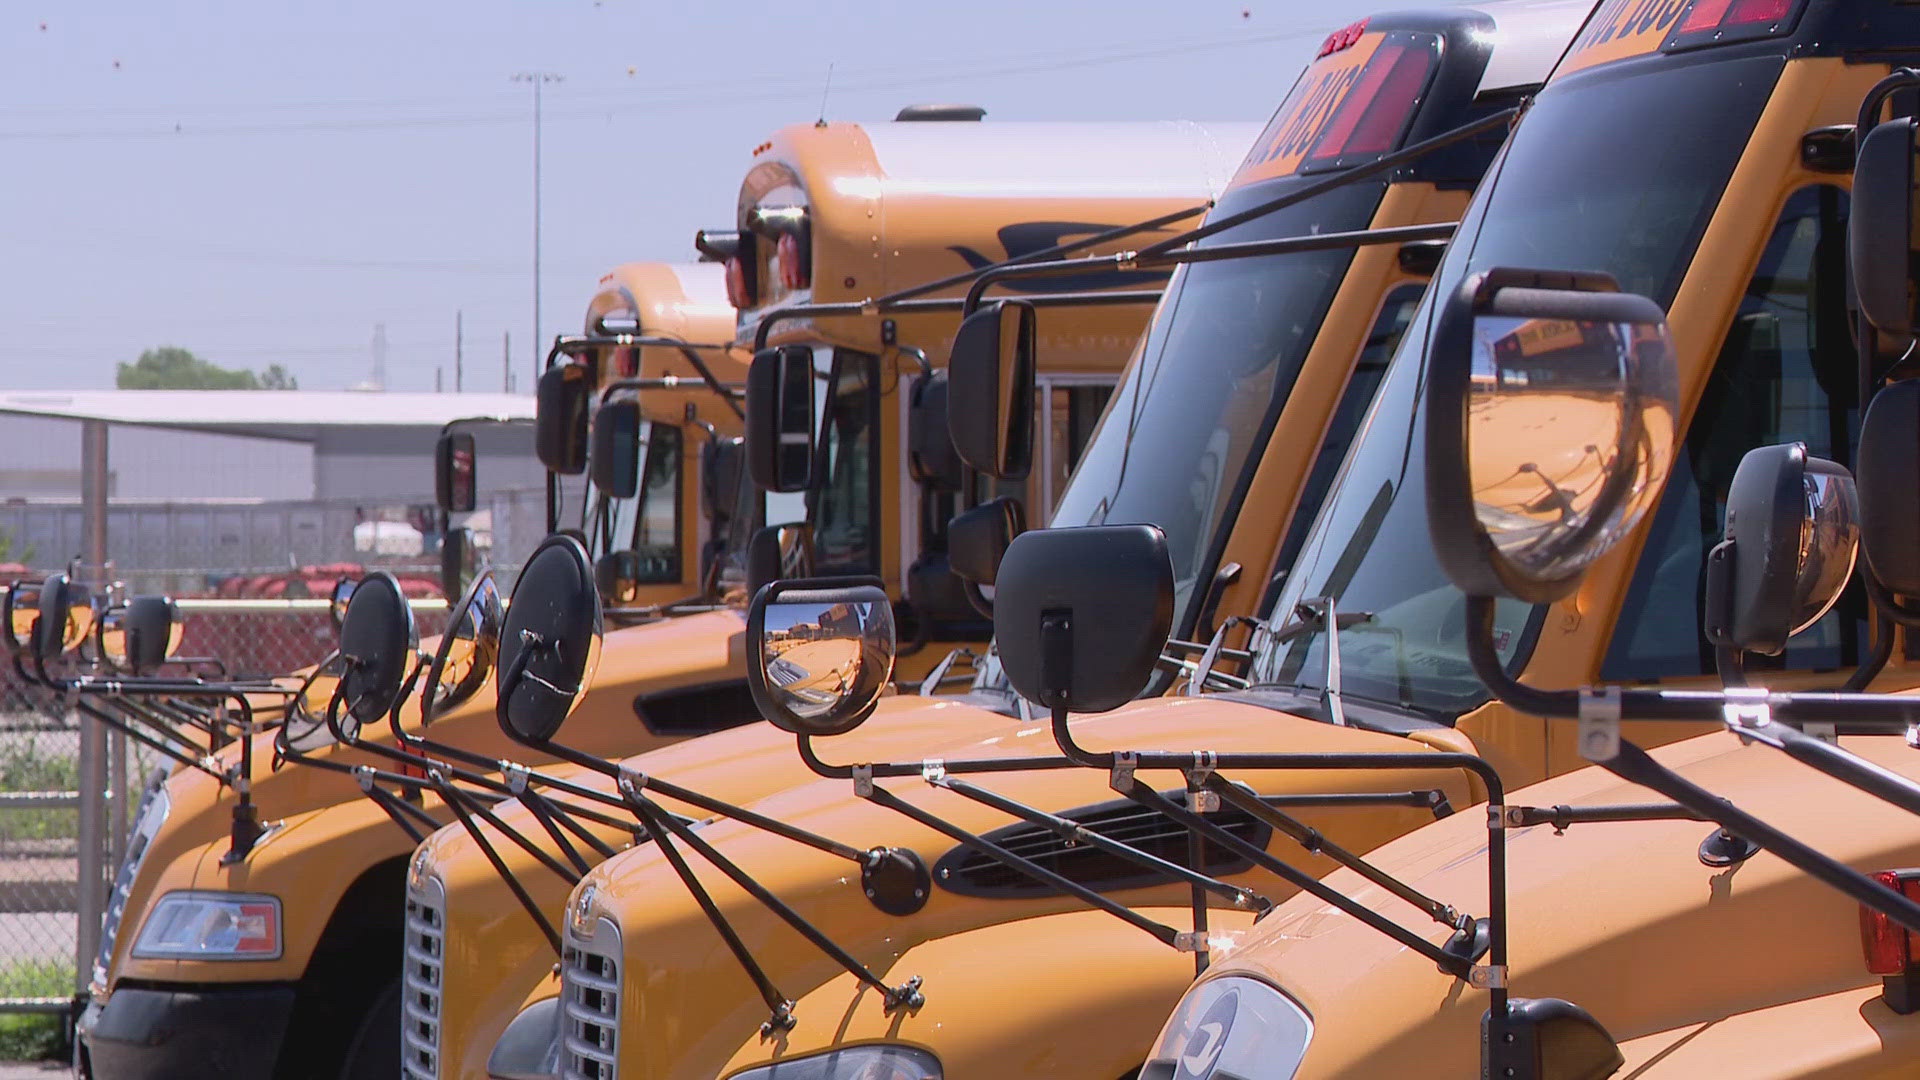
[{"x1": 1434, "y1": 276, "x2": 1676, "y2": 601}]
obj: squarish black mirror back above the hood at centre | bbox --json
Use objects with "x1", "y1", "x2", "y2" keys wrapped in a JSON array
[{"x1": 993, "y1": 525, "x2": 1173, "y2": 713}]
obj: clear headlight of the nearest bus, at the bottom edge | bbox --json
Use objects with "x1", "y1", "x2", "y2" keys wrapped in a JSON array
[{"x1": 1140, "y1": 976, "x2": 1313, "y2": 1080}]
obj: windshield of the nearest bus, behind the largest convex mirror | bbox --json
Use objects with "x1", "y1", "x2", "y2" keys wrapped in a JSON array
[{"x1": 1254, "y1": 58, "x2": 1782, "y2": 721}]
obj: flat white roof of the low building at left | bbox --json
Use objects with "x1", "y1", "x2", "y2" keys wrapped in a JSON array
[{"x1": 0, "y1": 390, "x2": 534, "y2": 442}]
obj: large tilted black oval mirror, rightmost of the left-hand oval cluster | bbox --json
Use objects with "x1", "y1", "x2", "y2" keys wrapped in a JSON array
[{"x1": 493, "y1": 534, "x2": 601, "y2": 746}]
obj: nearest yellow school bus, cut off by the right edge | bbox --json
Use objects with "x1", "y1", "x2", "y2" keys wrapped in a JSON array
[{"x1": 1148, "y1": 0, "x2": 1920, "y2": 1078}]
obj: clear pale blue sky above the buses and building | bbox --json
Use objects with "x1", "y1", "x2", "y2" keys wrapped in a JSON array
[{"x1": 0, "y1": 0, "x2": 1405, "y2": 390}]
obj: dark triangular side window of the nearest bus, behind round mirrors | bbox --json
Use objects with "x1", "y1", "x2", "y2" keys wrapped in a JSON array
[{"x1": 1599, "y1": 184, "x2": 1864, "y2": 680}]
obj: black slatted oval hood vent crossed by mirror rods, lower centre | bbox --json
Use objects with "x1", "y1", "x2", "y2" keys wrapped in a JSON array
[{"x1": 933, "y1": 792, "x2": 1271, "y2": 899}]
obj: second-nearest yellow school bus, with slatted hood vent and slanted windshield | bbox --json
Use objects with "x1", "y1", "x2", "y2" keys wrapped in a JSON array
[{"x1": 439, "y1": 6, "x2": 1635, "y2": 1076}]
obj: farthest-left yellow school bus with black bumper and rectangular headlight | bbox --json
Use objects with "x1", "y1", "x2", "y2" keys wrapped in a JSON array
[{"x1": 77, "y1": 263, "x2": 745, "y2": 1074}]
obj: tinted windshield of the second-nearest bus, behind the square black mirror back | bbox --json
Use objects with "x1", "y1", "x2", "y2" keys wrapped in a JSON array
[{"x1": 1052, "y1": 179, "x2": 1384, "y2": 628}]
